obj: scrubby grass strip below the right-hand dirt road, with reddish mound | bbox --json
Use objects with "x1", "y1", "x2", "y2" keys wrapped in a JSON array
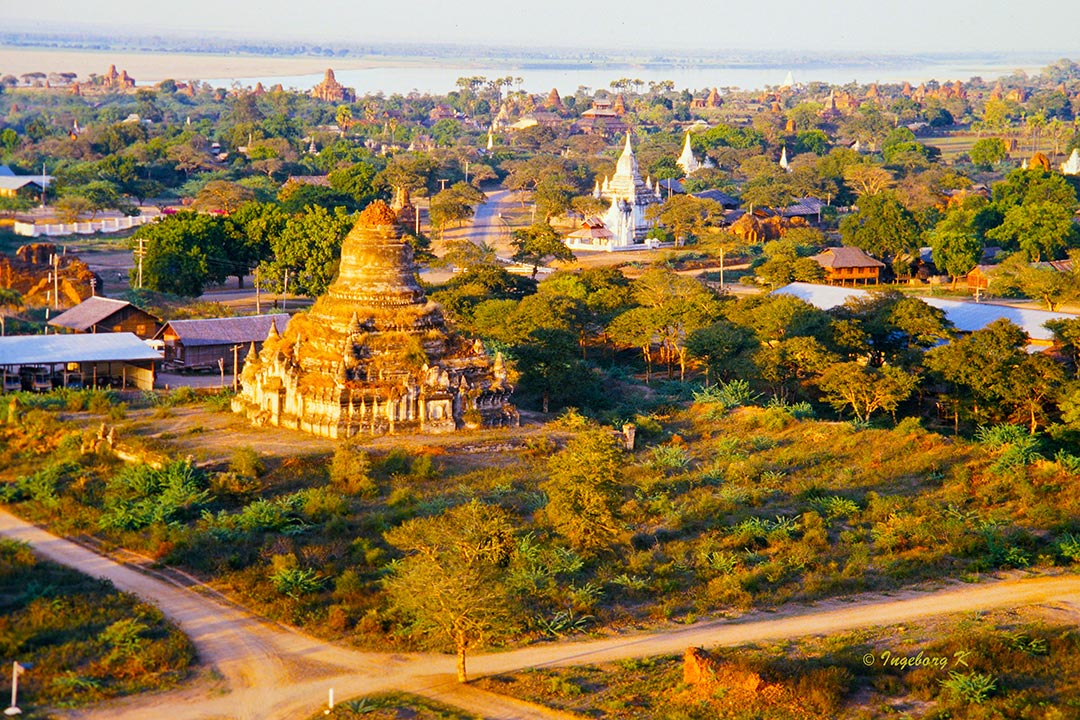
[{"x1": 478, "y1": 609, "x2": 1080, "y2": 720}]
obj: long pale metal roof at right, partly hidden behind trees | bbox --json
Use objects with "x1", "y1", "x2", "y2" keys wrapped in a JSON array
[{"x1": 773, "y1": 283, "x2": 1080, "y2": 342}]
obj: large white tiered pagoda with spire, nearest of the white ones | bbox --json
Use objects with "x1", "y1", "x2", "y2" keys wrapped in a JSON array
[{"x1": 583, "y1": 133, "x2": 663, "y2": 252}]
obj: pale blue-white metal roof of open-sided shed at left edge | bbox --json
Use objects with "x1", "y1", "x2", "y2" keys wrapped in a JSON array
[{"x1": 0, "y1": 332, "x2": 161, "y2": 365}]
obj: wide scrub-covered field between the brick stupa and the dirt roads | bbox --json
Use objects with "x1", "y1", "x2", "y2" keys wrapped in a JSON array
[{"x1": 0, "y1": 382, "x2": 1080, "y2": 648}]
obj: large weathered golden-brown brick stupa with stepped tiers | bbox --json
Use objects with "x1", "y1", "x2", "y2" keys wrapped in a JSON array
[{"x1": 232, "y1": 201, "x2": 517, "y2": 437}]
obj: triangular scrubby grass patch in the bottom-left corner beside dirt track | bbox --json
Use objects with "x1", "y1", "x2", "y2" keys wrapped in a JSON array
[{"x1": 0, "y1": 541, "x2": 194, "y2": 718}]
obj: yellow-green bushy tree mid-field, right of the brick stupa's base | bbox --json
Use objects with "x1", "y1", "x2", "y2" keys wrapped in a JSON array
[{"x1": 541, "y1": 429, "x2": 625, "y2": 555}]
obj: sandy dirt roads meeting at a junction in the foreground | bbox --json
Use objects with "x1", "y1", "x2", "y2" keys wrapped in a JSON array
[{"x1": 6, "y1": 510, "x2": 1080, "y2": 720}]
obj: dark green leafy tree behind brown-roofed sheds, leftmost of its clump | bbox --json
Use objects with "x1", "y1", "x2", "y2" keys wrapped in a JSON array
[{"x1": 132, "y1": 212, "x2": 230, "y2": 298}]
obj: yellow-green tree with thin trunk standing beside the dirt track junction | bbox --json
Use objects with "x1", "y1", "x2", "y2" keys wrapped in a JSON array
[{"x1": 383, "y1": 500, "x2": 516, "y2": 682}]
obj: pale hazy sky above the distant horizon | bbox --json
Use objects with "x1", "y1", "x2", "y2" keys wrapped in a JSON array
[{"x1": 0, "y1": 0, "x2": 1080, "y2": 56}]
